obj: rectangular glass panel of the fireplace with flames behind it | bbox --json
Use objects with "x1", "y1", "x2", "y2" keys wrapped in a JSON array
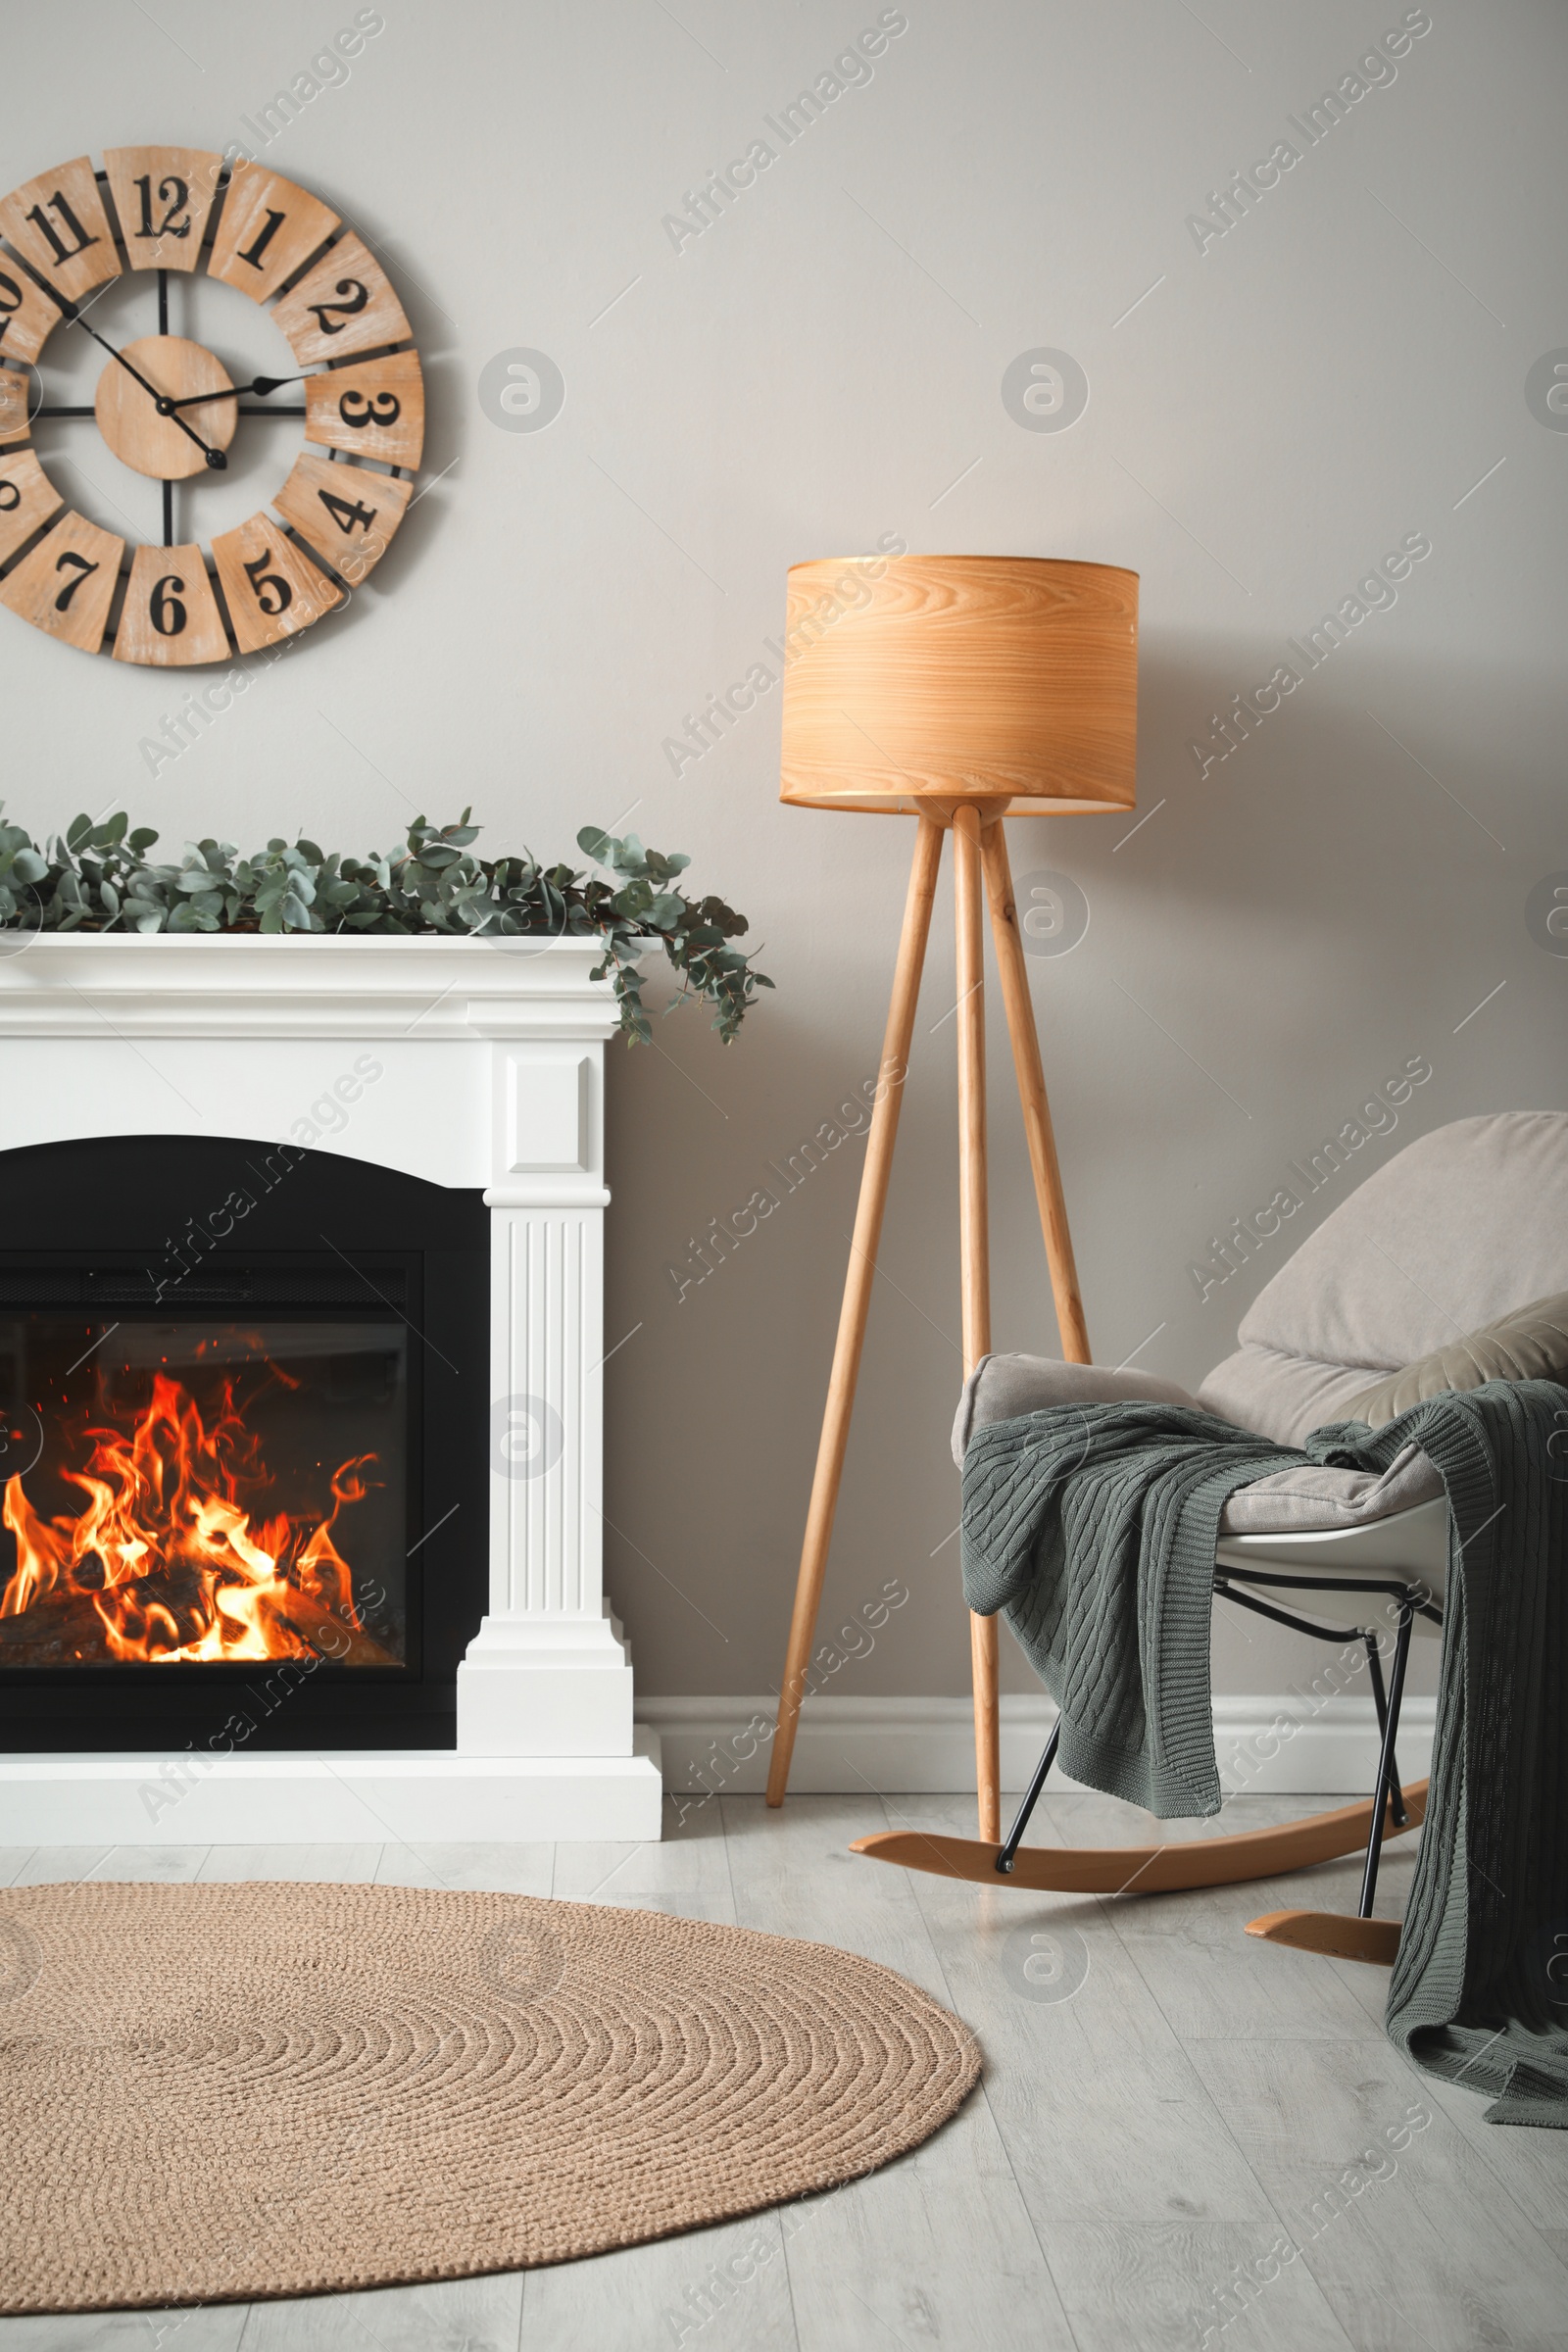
[{"x1": 0, "y1": 1310, "x2": 409, "y2": 1672}]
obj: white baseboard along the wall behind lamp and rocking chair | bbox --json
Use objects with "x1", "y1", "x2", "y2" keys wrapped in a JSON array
[{"x1": 637, "y1": 1693, "x2": 1437, "y2": 1797}]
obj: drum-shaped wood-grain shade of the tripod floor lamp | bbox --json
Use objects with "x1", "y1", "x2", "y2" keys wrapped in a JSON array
[{"x1": 780, "y1": 555, "x2": 1138, "y2": 821}]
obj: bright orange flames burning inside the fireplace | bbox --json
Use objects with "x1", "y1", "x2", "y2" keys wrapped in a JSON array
[{"x1": 0, "y1": 1371, "x2": 395, "y2": 1665}]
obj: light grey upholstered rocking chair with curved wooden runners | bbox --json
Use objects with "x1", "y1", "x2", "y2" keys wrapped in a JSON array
[{"x1": 854, "y1": 1105, "x2": 1568, "y2": 1966}]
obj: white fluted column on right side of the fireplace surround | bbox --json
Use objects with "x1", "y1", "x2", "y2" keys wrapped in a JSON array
[{"x1": 459, "y1": 1040, "x2": 632, "y2": 1757}]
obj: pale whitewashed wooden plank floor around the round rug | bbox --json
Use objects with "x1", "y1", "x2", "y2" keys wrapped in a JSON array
[{"x1": 0, "y1": 1792, "x2": 1568, "y2": 2352}]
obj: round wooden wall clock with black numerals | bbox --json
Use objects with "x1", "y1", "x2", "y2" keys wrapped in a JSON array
[{"x1": 0, "y1": 148, "x2": 425, "y2": 668}]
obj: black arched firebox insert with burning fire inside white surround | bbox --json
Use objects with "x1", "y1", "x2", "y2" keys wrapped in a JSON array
[{"x1": 0, "y1": 1136, "x2": 489, "y2": 1754}]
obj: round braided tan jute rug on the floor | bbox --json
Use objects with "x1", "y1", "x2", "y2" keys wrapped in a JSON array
[{"x1": 0, "y1": 1882, "x2": 980, "y2": 2312}]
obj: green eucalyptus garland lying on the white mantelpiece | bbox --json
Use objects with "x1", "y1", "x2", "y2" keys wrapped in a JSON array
[{"x1": 0, "y1": 802, "x2": 773, "y2": 1045}]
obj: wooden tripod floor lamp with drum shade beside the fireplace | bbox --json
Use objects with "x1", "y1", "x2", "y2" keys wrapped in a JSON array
[{"x1": 768, "y1": 555, "x2": 1138, "y2": 1841}]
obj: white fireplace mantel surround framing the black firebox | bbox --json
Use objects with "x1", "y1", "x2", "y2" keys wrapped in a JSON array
[{"x1": 0, "y1": 934, "x2": 661, "y2": 1844}]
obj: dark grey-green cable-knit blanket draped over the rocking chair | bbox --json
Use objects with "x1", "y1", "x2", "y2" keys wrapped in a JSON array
[{"x1": 964, "y1": 1381, "x2": 1568, "y2": 2129}]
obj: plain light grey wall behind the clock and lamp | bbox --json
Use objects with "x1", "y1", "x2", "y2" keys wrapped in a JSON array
[{"x1": 0, "y1": 0, "x2": 1568, "y2": 1695}]
